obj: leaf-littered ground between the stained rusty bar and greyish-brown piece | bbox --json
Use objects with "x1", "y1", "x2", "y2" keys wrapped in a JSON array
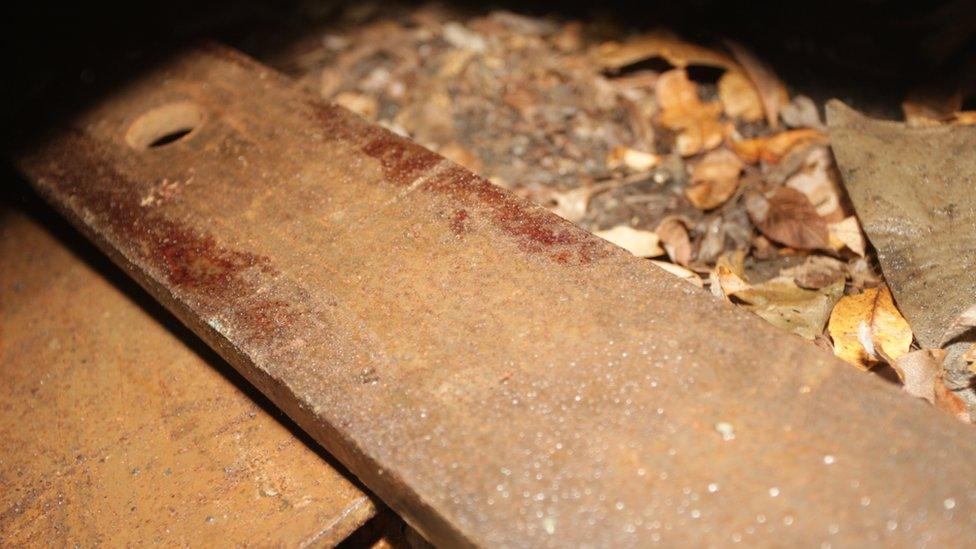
[{"x1": 276, "y1": 3, "x2": 976, "y2": 418}]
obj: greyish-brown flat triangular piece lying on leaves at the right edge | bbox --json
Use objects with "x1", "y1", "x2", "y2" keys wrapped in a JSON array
[{"x1": 827, "y1": 97, "x2": 976, "y2": 390}]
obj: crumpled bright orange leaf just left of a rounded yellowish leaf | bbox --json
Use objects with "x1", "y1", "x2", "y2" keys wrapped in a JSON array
[{"x1": 654, "y1": 69, "x2": 725, "y2": 156}]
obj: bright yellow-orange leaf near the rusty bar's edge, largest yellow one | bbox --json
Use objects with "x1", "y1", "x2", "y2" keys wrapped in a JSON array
[{"x1": 827, "y1": 286, "x2": 913, "y2": 370}]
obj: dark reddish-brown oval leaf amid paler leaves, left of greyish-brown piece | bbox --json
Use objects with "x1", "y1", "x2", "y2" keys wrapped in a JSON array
[{"x1": 746, "y1": 187, "x2": 829, "y2": 250}]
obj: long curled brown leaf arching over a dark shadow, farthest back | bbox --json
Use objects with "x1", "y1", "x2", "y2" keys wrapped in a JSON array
[{"x1": 596, "y1": 30, "x2": 736, "y2": 69}]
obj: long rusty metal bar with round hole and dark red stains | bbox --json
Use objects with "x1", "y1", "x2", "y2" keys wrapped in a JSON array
[{"x1": 11, "y1": 47, "x2": 976, "y2": 546}]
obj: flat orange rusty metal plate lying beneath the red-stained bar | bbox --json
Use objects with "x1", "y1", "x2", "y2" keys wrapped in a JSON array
[{"x1": 0, "y1": 205, "x2": 375, "y2": 547}]
